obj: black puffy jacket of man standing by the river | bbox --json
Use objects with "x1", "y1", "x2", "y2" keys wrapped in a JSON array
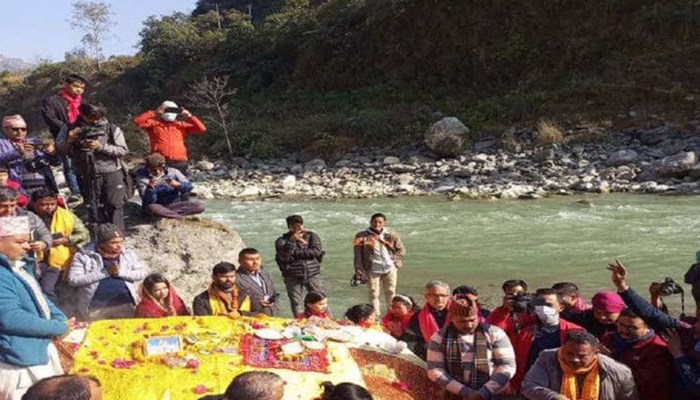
[{"x1": 275, "y1": 231, "x2": 325, "y2": 279}]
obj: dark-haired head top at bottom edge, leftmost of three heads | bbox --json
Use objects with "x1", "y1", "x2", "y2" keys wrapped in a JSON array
[{"x1": 22, "y1": 375, "x2": 102, "y2": 400}]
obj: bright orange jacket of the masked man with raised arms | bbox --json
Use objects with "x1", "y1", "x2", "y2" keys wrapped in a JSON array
[{"x1": 134, "y1": 111, "x2": 207, "y2": 161}]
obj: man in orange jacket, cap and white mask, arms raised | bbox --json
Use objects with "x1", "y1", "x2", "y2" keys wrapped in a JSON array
[{"x1": 134, "y1": 100, "x2": 207, "y2": 175}]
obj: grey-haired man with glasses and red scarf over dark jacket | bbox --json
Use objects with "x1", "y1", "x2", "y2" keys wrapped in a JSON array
[{"x1": 401, "y1": 281, "x2": 450, "y2": 360}]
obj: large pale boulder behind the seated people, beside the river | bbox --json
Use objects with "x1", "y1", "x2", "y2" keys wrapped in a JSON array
[{"x1": 127, "y1": 218, "x2": 245, "y2": 304}]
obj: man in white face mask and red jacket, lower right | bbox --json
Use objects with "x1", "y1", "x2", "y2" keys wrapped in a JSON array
[{"x1": 506, "y1": 289, "x2": 584, "y2": 394}]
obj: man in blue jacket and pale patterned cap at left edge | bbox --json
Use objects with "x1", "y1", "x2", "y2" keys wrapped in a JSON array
[{"x1": 0, "y1": 217, "x2": 68, "y2": 400}]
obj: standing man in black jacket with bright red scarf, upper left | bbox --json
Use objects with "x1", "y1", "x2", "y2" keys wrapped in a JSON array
[{"x1": 41, "y1": 74, "x2": 86, "y2": 202}]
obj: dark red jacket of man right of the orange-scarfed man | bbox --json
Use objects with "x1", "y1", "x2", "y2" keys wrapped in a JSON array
[{"x1": 600, "y1": 332, "x2": 673, "y2": 400}]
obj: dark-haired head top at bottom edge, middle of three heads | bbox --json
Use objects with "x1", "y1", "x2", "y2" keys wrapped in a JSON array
[{"x1": 200, "y1": 371, "x2": 285, "y2": 400}]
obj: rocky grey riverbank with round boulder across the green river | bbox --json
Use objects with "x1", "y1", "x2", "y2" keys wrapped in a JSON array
[{"x1": 192, "y1": 118, "x2": 700, "y2": 200}]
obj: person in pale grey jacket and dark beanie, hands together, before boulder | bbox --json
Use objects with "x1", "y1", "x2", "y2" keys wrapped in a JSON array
[{"x1": 68, "y1": 224, "x2": 148, "y2": 321}]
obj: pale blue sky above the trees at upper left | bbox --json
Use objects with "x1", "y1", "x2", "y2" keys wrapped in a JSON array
[{"x1": 0, "y1": 0, "x2": 196, "y2": 62}]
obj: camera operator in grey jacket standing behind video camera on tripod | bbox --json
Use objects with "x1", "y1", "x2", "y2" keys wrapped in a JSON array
[{"x1": 57, "y1": 104, "x2": 130, "y2": 233}]
